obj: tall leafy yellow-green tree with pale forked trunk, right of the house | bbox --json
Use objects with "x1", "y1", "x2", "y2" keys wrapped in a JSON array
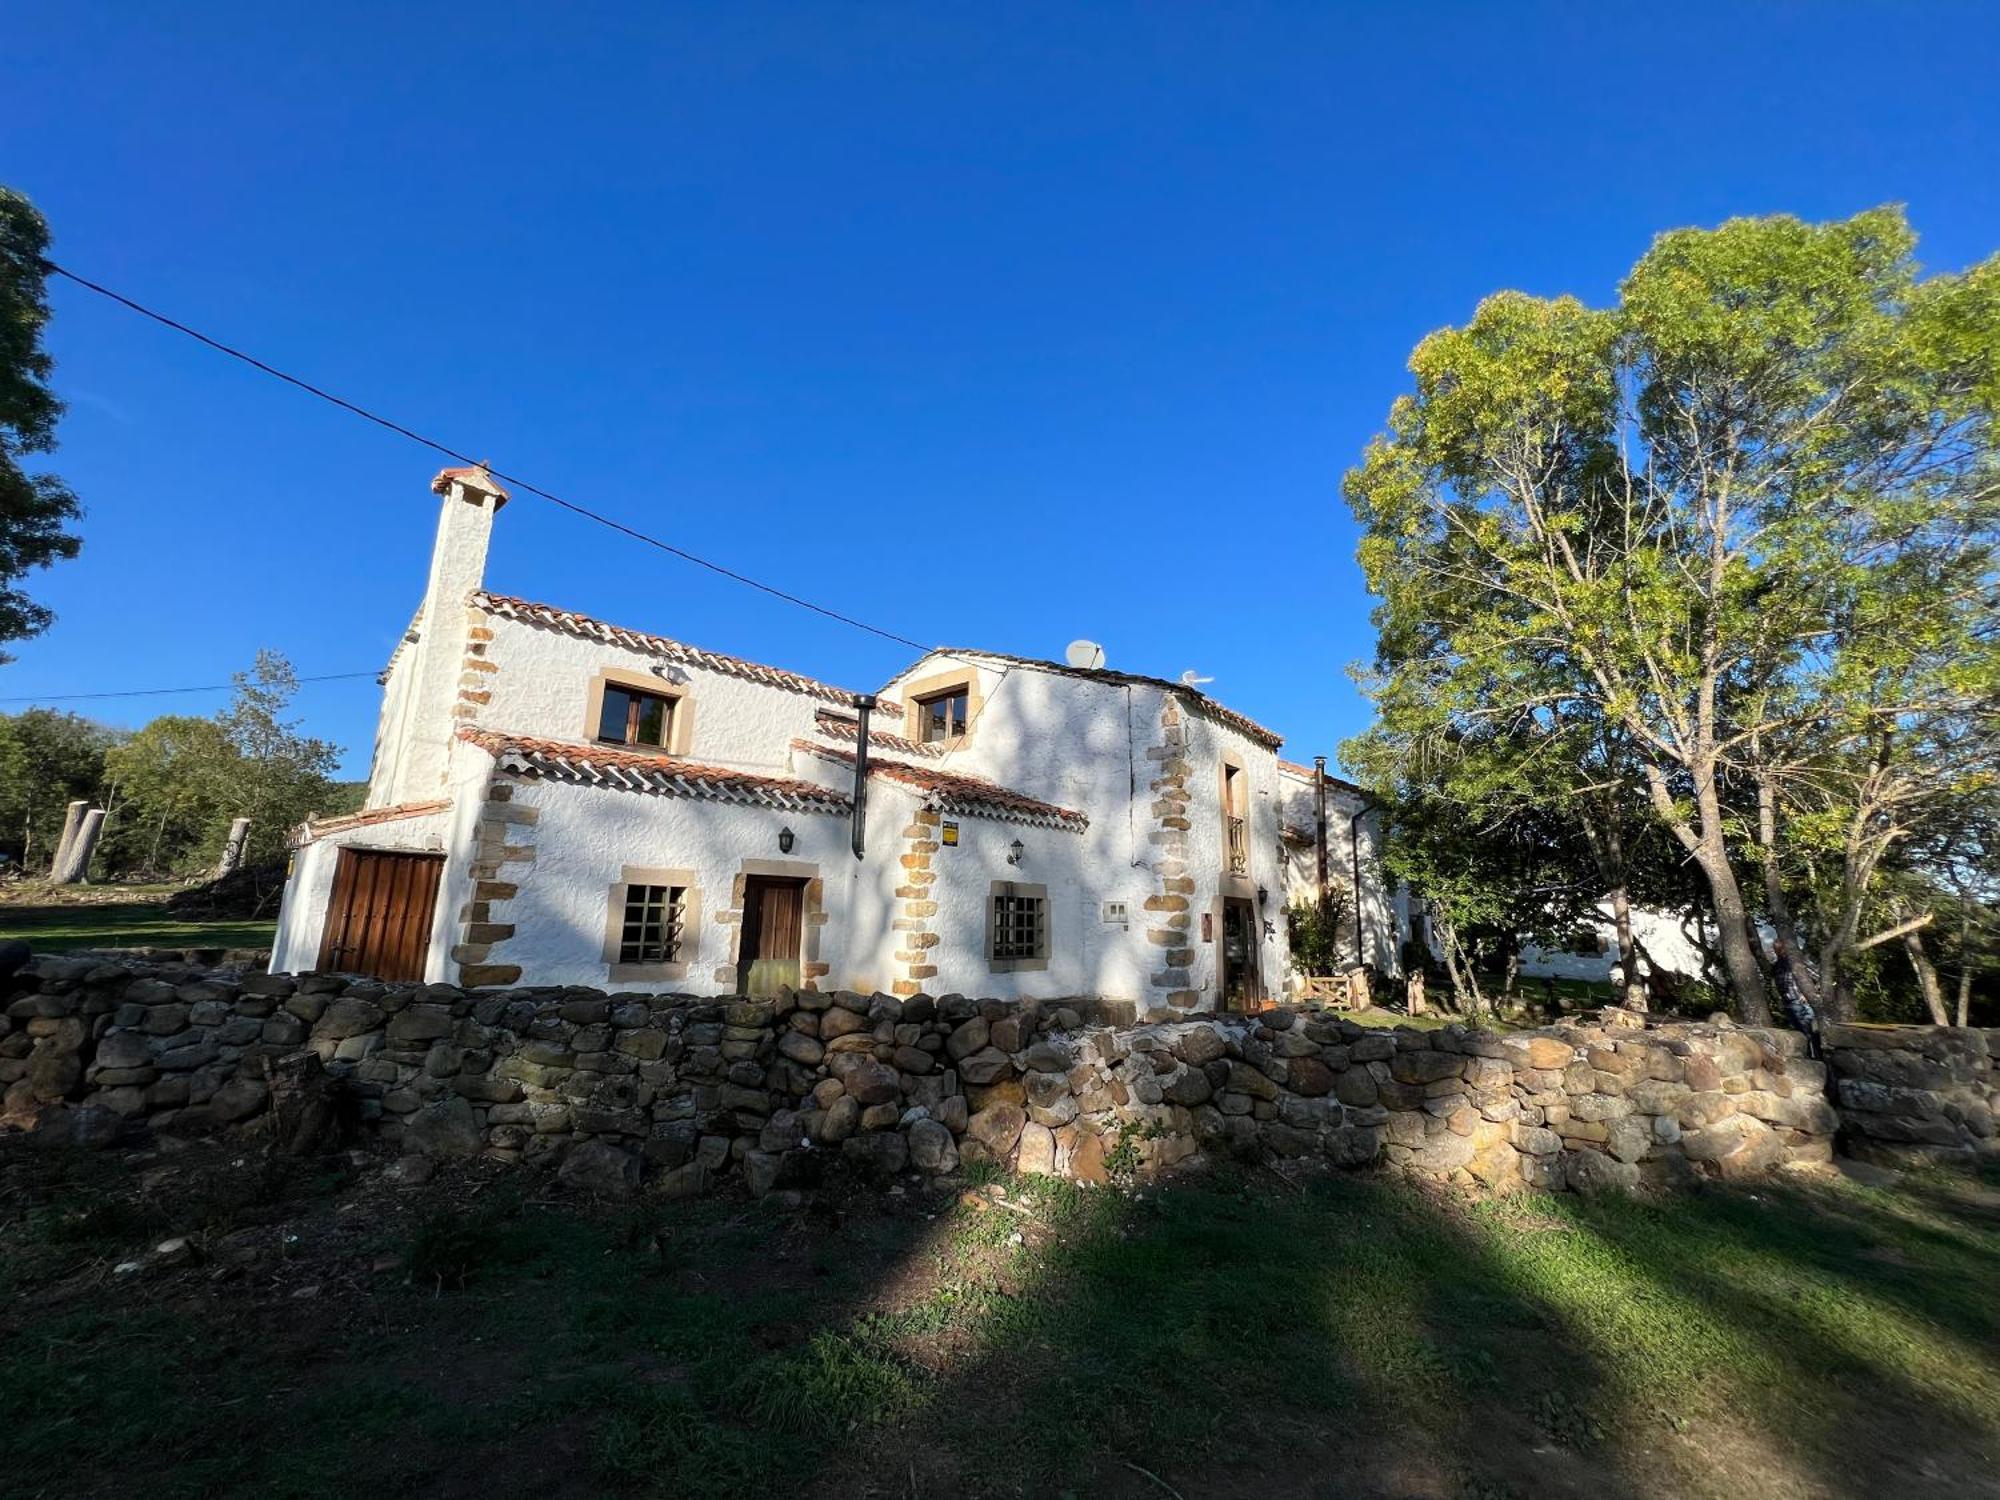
[{"x1": 1346, "y1": 210, "x2": 2000, "y2": 1020}]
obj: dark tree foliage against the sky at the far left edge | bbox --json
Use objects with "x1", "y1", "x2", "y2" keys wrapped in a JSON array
[{"x1": 0, "y1": 188, "x2": 82, "y2": 662}]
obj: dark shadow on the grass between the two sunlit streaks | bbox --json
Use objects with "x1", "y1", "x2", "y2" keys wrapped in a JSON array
[{"x1": 812, "y1": 1174, "x2": 1660, "y2": 1500}]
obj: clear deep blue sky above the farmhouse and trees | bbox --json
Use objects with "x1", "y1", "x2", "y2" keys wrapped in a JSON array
[{"x1": 0, "y1": 0, "x2": 2000, "y2": 774}]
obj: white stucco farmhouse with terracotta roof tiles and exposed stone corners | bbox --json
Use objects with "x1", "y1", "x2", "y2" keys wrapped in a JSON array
[{"x1": 272, "y1": 468, "x2": 1394, "y2": 1010}]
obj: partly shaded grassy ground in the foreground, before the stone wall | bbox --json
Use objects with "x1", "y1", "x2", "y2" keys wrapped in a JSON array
[{"x1": 0, "y1": 1144, "x2": 2000, "y2": 1500}]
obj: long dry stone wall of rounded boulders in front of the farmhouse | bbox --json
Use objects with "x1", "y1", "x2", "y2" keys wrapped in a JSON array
[{"x1": 0, "y1": 956, "x2": 1856, "y2": 1192}]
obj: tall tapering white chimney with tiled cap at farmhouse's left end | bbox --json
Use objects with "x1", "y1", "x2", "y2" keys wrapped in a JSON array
[{"x1": 368, "y1": 464, "x2": 508, "y2": 804}]
